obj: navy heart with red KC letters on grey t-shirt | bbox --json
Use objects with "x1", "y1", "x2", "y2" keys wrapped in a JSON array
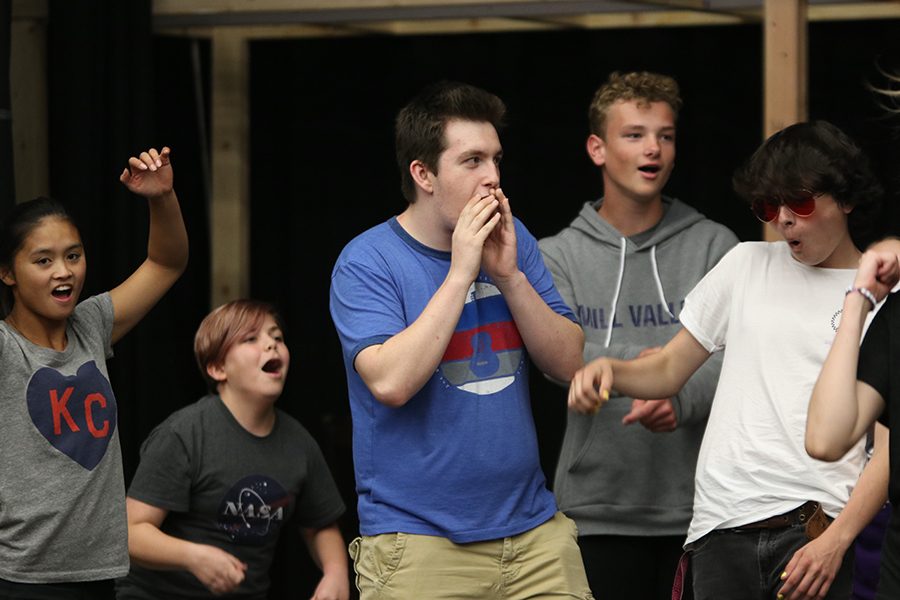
[{"x1": 25, "y1": 361, "x2": 117, "y2": 471}]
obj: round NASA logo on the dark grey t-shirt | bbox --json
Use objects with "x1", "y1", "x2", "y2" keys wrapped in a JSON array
[{"x1": 218, "y1": 475, "x2": 292, "y2": 545}]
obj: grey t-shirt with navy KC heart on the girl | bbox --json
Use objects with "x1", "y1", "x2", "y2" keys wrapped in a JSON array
[{"x1": 0, "y1": 293, "x2": 128, "y2": 583}]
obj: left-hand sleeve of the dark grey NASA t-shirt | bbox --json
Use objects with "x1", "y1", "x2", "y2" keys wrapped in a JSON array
[{"x1": 128, "y1": 422, "x2": 192, "y2": 512}]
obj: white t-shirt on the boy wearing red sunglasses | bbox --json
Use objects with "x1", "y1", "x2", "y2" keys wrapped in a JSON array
[{"x1": 680, "y1": 242, "x2": 871, "y2": 543}]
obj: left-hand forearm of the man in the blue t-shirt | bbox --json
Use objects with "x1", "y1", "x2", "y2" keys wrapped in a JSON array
[{"x1": 356, "y1": 274, "x2": 471, "y2": 406}]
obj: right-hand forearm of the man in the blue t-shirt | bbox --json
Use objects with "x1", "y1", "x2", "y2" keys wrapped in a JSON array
[{"x1": 496, "y1": 271, "x2": 584, "y2": 381}]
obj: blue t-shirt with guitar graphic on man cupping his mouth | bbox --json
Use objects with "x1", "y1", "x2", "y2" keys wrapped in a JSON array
[{"x1": 331, "y1": 219, "x2": 574, "y2": 543}]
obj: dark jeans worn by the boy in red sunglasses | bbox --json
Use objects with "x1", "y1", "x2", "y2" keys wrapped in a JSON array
[{"x1": 688, "y1": 525, "x2": 853, "y2": 600}]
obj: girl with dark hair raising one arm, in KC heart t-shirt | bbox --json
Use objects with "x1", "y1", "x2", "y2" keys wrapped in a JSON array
[{"x1": 0, "y1": 148, "x2": 188, "y2": 600}]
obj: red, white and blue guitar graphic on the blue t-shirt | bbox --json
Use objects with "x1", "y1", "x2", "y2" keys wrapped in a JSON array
[{"x1": 439, "y1": 281, "x2": 524, "y2": 396}]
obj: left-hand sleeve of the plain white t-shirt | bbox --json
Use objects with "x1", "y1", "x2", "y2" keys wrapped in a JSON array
[{"x1": 679, "y1": 244, "x2": 747, "y2": 352}]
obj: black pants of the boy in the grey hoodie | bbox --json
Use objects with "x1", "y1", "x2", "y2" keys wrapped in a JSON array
[{"x1": 578, "y1": 535, "x2": 692, "y2": 600}]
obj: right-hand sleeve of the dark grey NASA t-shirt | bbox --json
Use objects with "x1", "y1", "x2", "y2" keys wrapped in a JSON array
[{"x1": 294, "y1": 429, "x2": 346, "y2": 529}]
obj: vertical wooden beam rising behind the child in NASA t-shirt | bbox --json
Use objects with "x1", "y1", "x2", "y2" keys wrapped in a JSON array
[{"x1": 209, "y1": 28, "x2": 250, "y2": 308}]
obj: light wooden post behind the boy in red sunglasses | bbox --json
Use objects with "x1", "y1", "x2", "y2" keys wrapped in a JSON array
[{"x1": 763, "y1": 0, "x2": 808, "y2": 241}]
